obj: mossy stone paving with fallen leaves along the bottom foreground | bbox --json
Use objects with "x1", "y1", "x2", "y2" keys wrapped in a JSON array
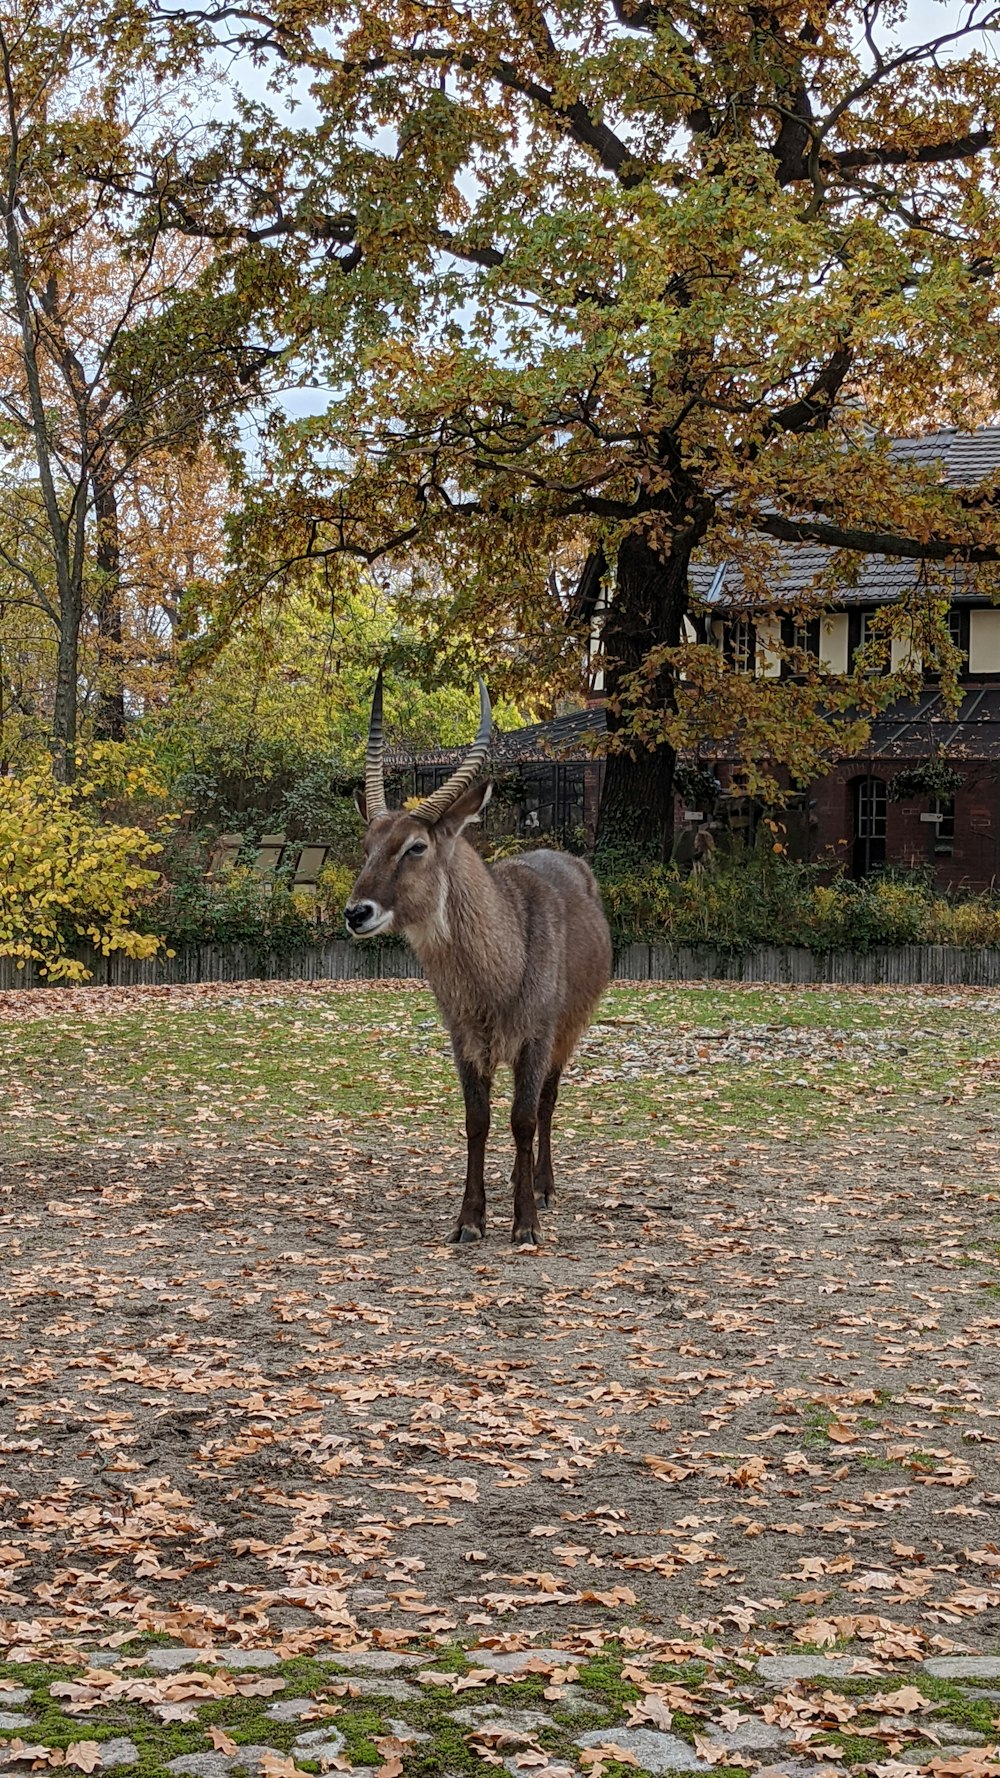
[{"x1": 0, "y1": 1645, "x2": 1000, "y2": 1778}]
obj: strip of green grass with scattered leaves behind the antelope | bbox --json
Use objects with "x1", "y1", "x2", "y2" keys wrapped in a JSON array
[{"x1": 0, "y1": 983, "x2": 991, "y2": 1159}]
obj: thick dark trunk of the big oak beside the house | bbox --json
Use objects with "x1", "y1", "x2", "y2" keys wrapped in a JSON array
[{"x1": 596, "y1": 532, "x2": 694, "y2": 862}]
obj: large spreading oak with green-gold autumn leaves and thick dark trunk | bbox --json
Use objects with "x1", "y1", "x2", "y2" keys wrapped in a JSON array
[{"x1": 157, "y1": 0, "x2": 1000, "y2": 850}]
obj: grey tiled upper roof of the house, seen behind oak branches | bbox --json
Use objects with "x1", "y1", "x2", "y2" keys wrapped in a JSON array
[{"x1": 690, "y1": 427, "x2": 1000, "y2": 606}]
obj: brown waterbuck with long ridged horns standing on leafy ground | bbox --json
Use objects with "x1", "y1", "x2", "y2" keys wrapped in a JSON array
[{"x1": 345, "y1": 674, "x2": 610, "y2": 1246}]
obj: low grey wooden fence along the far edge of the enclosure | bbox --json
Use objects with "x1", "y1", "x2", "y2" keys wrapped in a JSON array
[{"x1": 0, "y1": 939, "x2": 1000, "y2": 989}]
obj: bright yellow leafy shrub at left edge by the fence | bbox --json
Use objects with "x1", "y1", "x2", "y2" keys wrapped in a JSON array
[{"x1": 0, "y1": 770, "x2": 160, "y2": 981}]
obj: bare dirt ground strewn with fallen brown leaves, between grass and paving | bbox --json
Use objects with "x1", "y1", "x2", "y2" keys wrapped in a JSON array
[{"x1": 0, "y1": 1002, "x2": 1000, "y2": 1678}]
